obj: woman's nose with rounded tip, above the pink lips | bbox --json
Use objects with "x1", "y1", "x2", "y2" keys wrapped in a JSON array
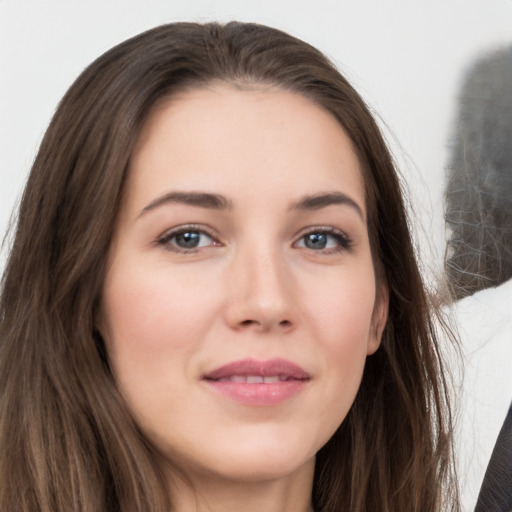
[{"x1": 226, "y1": 247, "x2": 298, "y2": 333}]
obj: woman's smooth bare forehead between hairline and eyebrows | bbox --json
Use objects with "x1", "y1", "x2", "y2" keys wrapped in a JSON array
[{"x1": 127, "y1": 83, "x2": 365, "y2": 209}]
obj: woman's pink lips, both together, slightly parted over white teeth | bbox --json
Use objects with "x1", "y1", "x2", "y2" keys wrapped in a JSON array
[{"x1": 203, "y1": 359, "x2": 311, "y2": 406}]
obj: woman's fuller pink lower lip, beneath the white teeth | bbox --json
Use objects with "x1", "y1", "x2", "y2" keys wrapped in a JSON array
[{"x1": 205, "y1": 379, "x2": 308, "y2": 406}]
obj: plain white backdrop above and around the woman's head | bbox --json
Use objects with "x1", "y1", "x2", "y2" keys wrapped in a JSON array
[{"x1": 0, "y1": 0, "x2": 512, "y2": 508}]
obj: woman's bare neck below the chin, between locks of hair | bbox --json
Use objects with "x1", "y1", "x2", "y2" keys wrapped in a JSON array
[{"x1": 169, "y1": 463, "x2": 314, "y2": 512}]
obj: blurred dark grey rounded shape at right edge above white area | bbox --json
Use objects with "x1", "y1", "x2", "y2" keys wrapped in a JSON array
[{"x1": 445, "y1": 47, "x2": 512, "y2": 300}]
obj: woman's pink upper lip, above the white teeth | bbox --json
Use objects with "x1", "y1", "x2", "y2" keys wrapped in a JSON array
[{"x1": 203, "y1": 358, "x2": 310, "y2": 380}]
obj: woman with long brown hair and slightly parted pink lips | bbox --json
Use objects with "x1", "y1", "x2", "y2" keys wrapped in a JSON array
[{"x1": 0, "y1": 23, "x2": 456, "y2": 512}]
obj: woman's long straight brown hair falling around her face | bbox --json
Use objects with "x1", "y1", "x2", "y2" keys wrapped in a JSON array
[{"x1": 0, "y1": 23, "x2": 456, "y2": 512}]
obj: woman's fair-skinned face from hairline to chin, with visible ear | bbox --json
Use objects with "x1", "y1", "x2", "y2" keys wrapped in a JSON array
[{"x1": 98, "y1": 85, "x2": 387, "y2": 488}]
